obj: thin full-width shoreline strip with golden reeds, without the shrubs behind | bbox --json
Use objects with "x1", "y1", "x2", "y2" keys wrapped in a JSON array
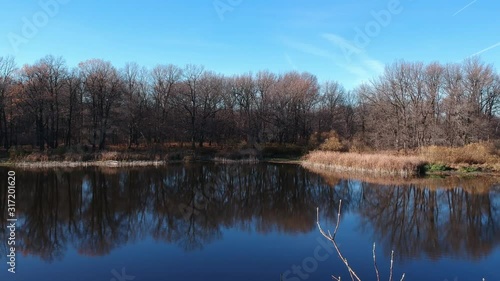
[{"x1": 0, "y1": 145, "x2": 500, "y2": 178}]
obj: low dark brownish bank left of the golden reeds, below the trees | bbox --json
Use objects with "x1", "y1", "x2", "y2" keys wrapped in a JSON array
[{"x1": 0, "y1": 143, "x2": 306, "y2": 167}]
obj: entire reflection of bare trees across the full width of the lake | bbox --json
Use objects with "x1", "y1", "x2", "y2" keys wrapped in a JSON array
[{"x1": 0, "y1": 164, "x2": 500, "y2": 261}]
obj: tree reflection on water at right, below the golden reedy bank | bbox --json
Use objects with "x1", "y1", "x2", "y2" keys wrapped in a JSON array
[{"x1": 359, "y1": 183, "x2": 500, "y2": 259}]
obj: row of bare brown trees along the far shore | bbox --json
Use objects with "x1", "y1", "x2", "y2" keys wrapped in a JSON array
[{"x1": 0, "y1": 56, "x2": 500, "y2": 151}]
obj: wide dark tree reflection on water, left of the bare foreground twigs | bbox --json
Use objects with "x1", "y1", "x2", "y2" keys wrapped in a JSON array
[{"x1": 0, "y1": 165, "x2": 340, "y2": 261}]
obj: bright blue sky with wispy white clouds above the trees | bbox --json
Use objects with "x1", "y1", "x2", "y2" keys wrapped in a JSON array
[{"x1": 0, "y1": 0, "x2": 500, "y2": 89}]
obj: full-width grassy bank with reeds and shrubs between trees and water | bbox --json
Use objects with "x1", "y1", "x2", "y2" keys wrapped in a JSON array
[{"x1": 6, "y1": 138, "x2": 500, "y2": 177}]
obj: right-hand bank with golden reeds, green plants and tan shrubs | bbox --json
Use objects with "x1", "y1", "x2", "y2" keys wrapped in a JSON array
[{"x1": 303, "y1": 142, "x2": 500, "y2": 177}]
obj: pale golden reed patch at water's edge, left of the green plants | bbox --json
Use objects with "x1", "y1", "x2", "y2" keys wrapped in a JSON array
[{"x1": 303, "y1": 151, "x2": 427, "y2": 177}]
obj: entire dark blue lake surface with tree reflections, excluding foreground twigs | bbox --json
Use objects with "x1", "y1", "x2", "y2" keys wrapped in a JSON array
[{"x1": 0, "y1": 164, "x2": 500, "y2": 281}]
